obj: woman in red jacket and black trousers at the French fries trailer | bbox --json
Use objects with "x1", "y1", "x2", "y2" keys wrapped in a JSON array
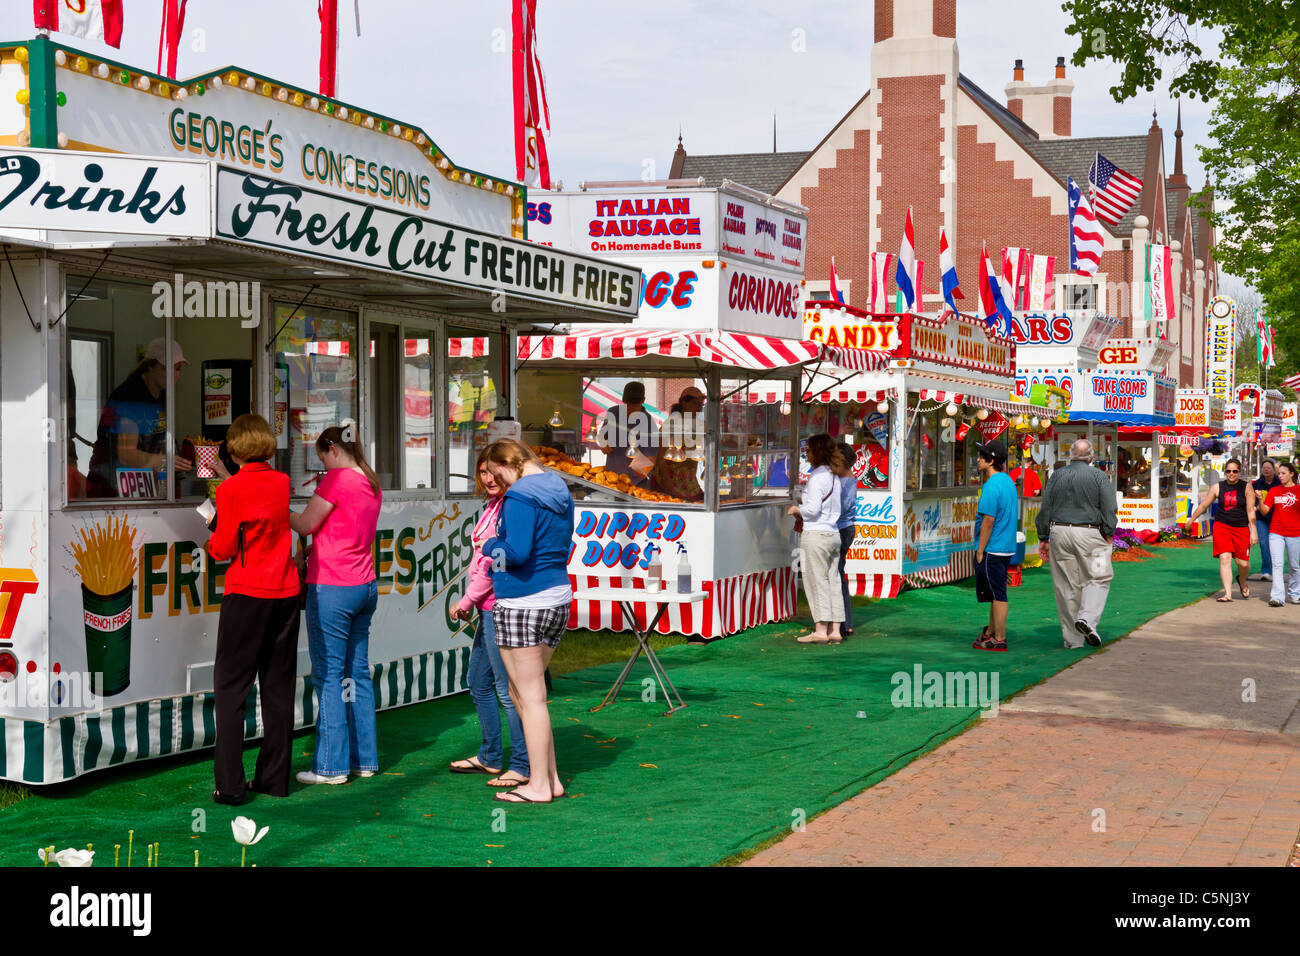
[{"x1": 208, "y1": 415, "x2": 299, "y2": 804}]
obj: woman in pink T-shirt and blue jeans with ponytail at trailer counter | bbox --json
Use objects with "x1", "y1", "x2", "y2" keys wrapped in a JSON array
[{"x1": 289, "y1": 425, "x2": 384, "y2": 783}]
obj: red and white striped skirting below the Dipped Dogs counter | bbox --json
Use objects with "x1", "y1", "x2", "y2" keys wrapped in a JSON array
[{"x1": 568, "y1": 567, "x2": 797, "y2": 637}]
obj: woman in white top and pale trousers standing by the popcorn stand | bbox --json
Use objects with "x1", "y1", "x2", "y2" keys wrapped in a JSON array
[{"x1": 788, "y1": 434, "x2": 845, "y2": 644}]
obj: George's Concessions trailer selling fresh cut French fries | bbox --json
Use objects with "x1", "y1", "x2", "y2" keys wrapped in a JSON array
[{"x1": 0, "y1": 38, "x2": 641, "y2": 784}]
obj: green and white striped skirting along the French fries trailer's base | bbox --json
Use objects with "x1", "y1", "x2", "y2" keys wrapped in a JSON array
[{"x1": 0, "y1": 646, "x2": 469, "y2": 784}]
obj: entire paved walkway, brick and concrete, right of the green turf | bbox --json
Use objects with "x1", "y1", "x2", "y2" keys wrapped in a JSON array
[{"x1": 745, "y1": 581, "x2": 1300, "y2": 866}]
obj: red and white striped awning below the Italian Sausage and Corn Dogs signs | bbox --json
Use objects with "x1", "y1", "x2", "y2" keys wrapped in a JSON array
[{"x1": 519, "y1": 329, "x2": 889, "y2": 372}]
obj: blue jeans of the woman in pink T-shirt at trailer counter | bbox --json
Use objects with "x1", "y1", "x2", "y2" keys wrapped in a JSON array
[{"x1": 307, "y1": 581, "x2": 380, "y2": 777}]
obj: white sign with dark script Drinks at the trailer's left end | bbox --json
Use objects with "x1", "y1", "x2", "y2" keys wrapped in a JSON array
[{"x1": 0, "y1": 148, "x2": 212, "y2": 239}]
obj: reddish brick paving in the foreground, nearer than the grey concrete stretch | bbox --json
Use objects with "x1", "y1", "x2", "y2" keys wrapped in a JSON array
[{"x1": 744, "y1": 711, "x2": 1300, "y2": 866}]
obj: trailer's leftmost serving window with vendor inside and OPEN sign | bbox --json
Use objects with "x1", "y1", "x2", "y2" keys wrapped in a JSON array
[{"x1": 64, "y1": 274, "x2": 254, "y2": 502}]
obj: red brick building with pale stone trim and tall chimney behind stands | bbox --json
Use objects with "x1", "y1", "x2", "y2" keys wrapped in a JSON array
[{"x1": 670, "y1": 0, "x2": 1218, "y2": 386}]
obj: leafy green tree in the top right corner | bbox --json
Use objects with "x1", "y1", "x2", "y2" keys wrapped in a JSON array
[{"x1": 1062, "y1": 0, "x2": 1300, "y2": 392}]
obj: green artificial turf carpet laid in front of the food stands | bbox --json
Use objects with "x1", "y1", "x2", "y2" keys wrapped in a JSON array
[{"x1": 0, "y1": 545, "x2": 1218, "y2": 866}]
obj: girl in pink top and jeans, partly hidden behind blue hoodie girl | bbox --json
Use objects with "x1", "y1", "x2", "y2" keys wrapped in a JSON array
[{"x1": 451, "y1": 449, "x2": 529, "y2": 787}]
